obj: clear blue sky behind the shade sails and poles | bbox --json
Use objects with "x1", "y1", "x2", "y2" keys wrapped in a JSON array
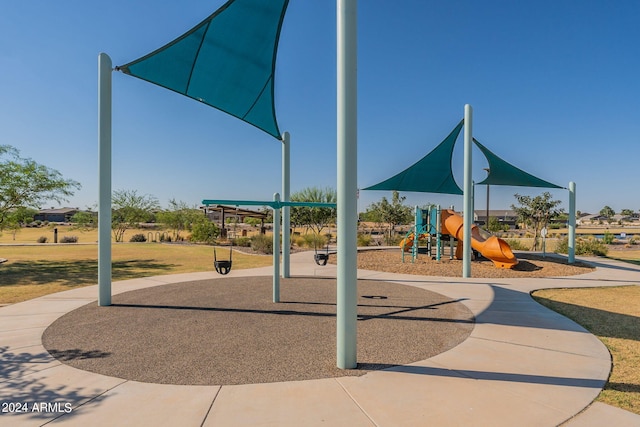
[{"x1": 0, "y1": 0, "x2": 640, "y2": 212}]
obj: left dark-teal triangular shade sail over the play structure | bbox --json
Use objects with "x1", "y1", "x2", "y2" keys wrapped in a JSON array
[{"x1": 364, "y1": 120, "x2": 464, "y2": 194}]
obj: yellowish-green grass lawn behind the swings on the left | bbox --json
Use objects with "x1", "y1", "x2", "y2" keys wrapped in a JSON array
[{"x1": 0, "y1": 243, "x2": 273, "y2": 304}]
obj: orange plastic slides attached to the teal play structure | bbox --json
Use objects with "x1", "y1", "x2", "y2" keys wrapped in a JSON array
[{"x1": 400, "y1": 209, "x2": 518, "y2": 268}]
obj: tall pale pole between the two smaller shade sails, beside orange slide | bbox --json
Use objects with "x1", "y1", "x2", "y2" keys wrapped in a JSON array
[{"x1": 462, "y1": 104, "x2": 473, "y2": 277}]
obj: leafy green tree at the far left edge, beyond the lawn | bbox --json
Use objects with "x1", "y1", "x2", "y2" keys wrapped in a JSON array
[{"x1": 0, "y1": 145, "x2": 80, "y2": 230}]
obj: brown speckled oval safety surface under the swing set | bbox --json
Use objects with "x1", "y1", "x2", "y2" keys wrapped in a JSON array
[{"x1": 43, "y1": 276, "x2": 474, "y2": 385}]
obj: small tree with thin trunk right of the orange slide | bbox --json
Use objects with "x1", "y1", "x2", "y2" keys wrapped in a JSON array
[{"x1": 511, "y1": 191, "x2": 564, "y2": 251}]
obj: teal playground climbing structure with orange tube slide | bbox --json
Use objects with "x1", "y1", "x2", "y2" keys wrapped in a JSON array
[{"x1": 400, "y1": 206, "x2": 518, "y2": 268}]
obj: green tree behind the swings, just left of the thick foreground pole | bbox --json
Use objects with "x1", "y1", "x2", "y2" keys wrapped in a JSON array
[{"x1": 290, "y1": 187, "x2": 338, "y2": 234}]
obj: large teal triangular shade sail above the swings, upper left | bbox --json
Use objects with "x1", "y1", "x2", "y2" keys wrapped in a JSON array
[{"x1": 116, "y1": 0, "x2": 289, "y2": 139}]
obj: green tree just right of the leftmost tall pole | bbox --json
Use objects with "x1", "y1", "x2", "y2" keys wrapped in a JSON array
[{"x1": 111, "y1": 190, "x2": 160, "y2": 242}]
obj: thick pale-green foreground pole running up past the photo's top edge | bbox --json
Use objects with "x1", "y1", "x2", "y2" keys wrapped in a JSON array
[{"x1": 336, "y1": 0, "x2": 358, "y2": 369}]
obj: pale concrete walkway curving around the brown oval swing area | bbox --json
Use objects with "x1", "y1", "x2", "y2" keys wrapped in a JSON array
[{"x1": 0, "y1": 252, "x2": 640, "y2": 427}]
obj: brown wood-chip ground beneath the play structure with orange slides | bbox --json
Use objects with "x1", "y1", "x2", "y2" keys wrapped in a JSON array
[{"x1": 329, "y1": 249, "x2": 593, "y2": 278}]
